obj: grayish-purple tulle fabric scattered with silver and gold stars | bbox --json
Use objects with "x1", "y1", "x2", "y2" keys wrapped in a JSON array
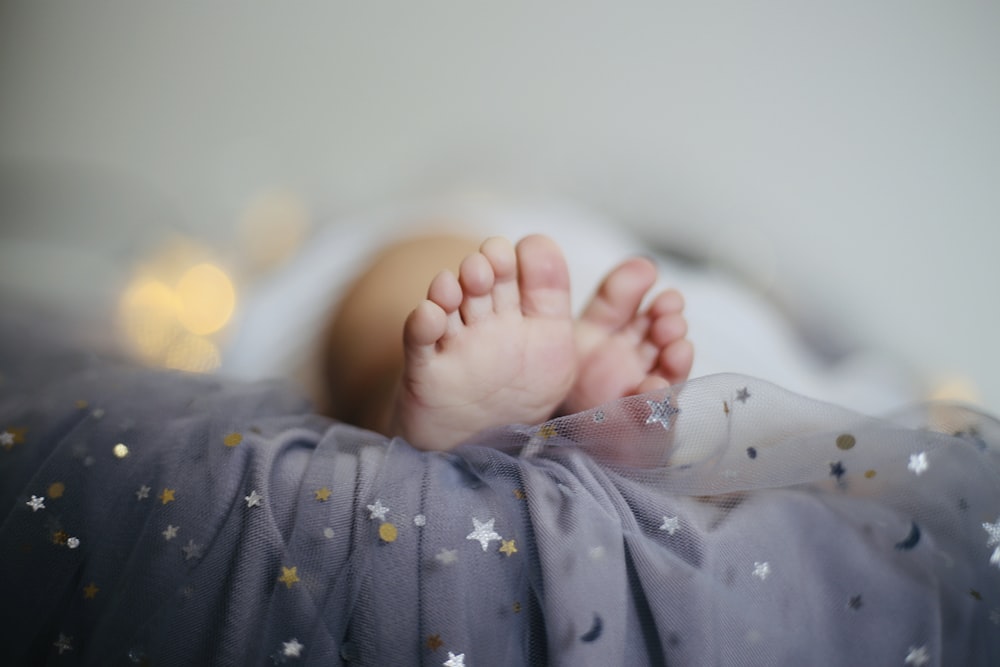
[{"x1": 0, "y1": 320, "x2": 1000, "y2": 667}]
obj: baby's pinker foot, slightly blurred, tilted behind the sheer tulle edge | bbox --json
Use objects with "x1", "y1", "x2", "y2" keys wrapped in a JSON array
[{"x1": 562, "y1": 258, "x2": 694, "y2": 413}]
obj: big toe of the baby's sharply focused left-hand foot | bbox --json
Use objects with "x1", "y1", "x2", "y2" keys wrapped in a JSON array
[{"x1": 516, "y1": 234, "x2": 571, "y2": 318}]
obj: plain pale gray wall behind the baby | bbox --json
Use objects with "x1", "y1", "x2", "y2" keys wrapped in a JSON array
[{"x1": 0, "y1": 0, "x2": 1000, "y2": 410}]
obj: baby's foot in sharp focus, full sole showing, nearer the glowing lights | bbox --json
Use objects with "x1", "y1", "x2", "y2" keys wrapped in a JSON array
[{"x1": 390, "y1": 236, "x2": 576, "y2": 450}]
